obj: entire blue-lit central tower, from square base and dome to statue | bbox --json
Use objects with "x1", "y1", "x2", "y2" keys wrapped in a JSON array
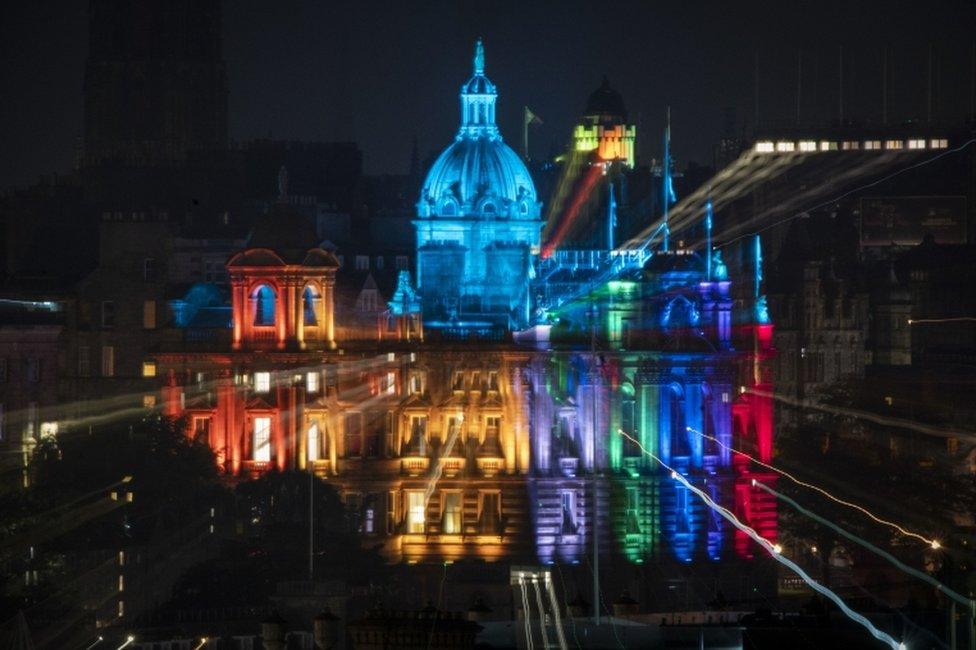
[{"x1": 414, "y1": 40, "x2": 542, "y2": 327}]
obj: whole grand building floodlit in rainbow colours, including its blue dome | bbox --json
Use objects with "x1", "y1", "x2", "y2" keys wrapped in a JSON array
[{"x1": 156, "y1": 43, "x2": 776, "y2": 563}]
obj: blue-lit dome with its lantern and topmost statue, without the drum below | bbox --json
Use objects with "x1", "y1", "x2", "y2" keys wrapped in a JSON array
[{"x1": 417, "y1": 41, "x2": 541, "y2": 219}]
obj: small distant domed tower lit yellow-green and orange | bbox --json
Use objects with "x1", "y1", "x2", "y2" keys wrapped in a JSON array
[{"x1": 573, "y1": 77, "x2": 637, "y2": 167}]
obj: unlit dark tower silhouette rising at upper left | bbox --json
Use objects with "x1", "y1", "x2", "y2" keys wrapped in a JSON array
[{"x1": 83, "y1": 0, "x2": 227, "y2": 166}]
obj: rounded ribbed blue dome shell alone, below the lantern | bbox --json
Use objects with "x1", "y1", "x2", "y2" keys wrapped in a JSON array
[{"x1": 417, "y1": 137, "x2": 540, "y2": 219}]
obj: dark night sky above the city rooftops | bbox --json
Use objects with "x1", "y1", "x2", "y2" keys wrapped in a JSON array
[{"x1": 0, "y1": 0, "x2": 976, "y2": 188}]
